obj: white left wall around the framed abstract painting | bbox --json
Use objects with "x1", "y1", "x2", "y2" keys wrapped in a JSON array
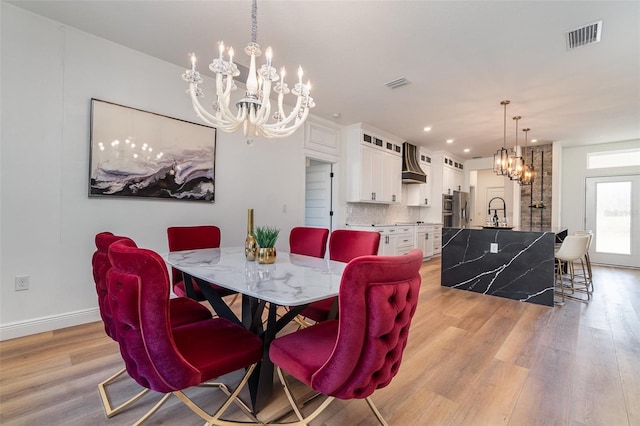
[{"x1": 0, "y1": 2, "x2": 305, "y2": 339}]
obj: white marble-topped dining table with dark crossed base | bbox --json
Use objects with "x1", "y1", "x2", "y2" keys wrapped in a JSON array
[{"x1": 161, "y1": 247, "x2": 347, "y2": 411}]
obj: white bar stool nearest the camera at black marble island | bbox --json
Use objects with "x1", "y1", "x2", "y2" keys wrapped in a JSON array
[{"x1": 555, "y1": 235, "x2": 591, "y2": 304}]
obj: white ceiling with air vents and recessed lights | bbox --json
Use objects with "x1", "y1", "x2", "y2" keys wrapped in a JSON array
[{"x1": 8, "y1": 0, "x2": 640, "y2": 158}]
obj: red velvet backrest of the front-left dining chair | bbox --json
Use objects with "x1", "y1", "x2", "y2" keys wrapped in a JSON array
[{"x1": 107, "y1": 241, "x2": 201, "y2": 393}]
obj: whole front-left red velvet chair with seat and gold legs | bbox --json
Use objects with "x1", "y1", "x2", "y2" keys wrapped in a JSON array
[{"x1": 107, "y1": 241, "x2": 262, "y2": 424}]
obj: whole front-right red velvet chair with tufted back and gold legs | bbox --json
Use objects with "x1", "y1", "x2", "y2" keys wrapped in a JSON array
[{"x1": 269, "y1": 249, "x2": 422, "y2": 425}]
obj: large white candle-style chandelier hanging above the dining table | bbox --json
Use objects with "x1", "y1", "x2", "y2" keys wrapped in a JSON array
[{"x1": 182, "y1": 0, "x2": 315, "y2": 143}]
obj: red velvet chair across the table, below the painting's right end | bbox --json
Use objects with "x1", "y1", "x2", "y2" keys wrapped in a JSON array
[{"x1": 167, "y1": 225, "x2": 237, "y2": 303}]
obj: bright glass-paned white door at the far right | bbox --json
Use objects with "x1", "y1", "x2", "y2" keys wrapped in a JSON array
[{"x1": 585, "y1": 175, "x2": 640, "y2": 267}]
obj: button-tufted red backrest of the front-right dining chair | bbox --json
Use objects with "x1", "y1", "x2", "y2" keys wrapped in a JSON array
[{"x1": 311, "y1": 249, "x2": 422, "y2": 399}]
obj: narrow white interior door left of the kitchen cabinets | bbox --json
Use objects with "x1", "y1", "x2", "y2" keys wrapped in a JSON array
[{"x1": 304, "y1": 160, "x2": 333, "y2": 230}]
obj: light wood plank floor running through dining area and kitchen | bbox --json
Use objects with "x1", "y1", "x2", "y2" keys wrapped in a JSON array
[{"x1": 0, "y1": 259, "x2": 640, "y2": 426}]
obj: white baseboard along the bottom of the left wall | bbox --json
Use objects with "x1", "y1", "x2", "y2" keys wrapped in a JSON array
[{"x1": 0, "y1": 308, "x2": 102, "y2": 341}]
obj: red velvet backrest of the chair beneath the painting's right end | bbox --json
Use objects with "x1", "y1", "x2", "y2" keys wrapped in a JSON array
[{"x1": 167, "y1": 225, "x2": 221, "y2": 286}]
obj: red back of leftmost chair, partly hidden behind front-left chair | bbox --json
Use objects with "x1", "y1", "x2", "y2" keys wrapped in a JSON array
[{"x1": 91, "y1": 232, "x2": 135, "y2": 340}]
